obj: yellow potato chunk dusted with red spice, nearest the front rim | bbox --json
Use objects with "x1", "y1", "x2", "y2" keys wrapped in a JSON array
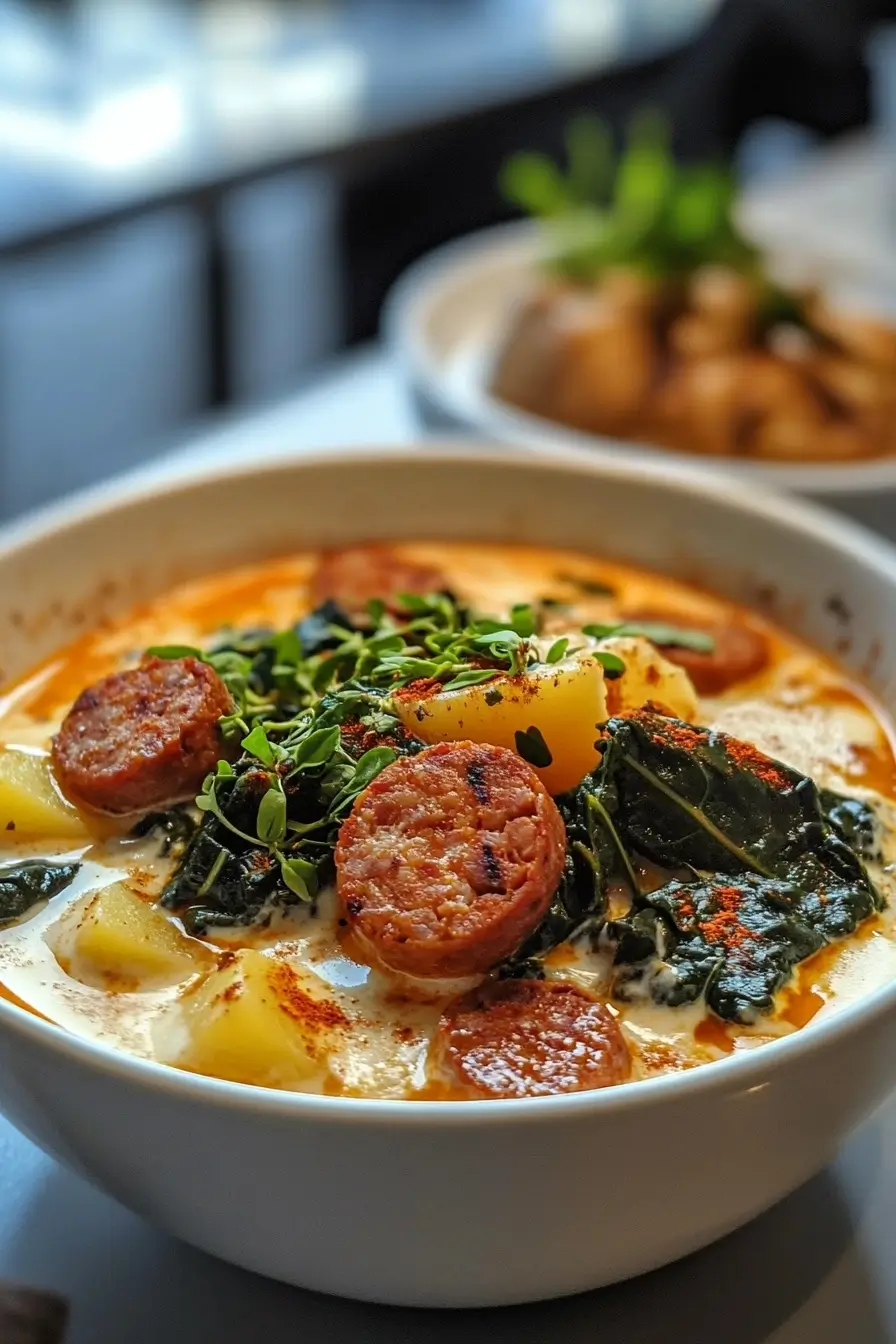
[{"x1": 154, "y1": 948, "x2": 339, "y2": 1089}]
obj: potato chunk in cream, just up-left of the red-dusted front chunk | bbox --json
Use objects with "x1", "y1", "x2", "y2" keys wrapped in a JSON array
[{"x1": 50, "y1": 882, "x2": 214, "y2": 991}]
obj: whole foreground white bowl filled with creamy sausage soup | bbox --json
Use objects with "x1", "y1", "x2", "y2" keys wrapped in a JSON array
[{"x1": 0, "y1": 448, "x2": 896, "y2": 1305}]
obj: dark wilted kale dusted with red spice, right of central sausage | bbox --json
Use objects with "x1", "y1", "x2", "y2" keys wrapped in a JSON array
[{"x1": 594, "y1": 711, "x2": 883, "y2": 1021}]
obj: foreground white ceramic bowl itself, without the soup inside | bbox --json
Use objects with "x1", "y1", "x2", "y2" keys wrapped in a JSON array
[{"x1": 0, "y1": 446, "x2": 896, "y2": 1306}]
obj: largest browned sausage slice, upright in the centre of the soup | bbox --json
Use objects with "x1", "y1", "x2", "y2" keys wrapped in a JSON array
[{"x1": 336, "y1": 742, "x2": 566, "y2": 977}]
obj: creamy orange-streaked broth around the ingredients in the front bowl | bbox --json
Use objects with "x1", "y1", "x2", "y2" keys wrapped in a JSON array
[{"x1": 0, "y1": 544, "x2": 896, "y2": 1099}]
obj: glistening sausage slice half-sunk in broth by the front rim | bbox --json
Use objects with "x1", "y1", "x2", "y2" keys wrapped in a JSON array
[{"x1": 435, "y1": 980, "x2": 631, "y2": 1097}]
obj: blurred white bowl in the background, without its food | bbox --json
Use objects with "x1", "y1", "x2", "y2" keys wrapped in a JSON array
[{"x1": 383, "y1": 222, "x2": 896, "y2": 538}]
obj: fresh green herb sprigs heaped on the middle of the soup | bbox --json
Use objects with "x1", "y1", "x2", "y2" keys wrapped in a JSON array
[{"x1": 148, "y1": 593, "x2": 697, "y2": 925}]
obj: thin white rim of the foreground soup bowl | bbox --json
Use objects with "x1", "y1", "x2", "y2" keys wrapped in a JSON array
[{"x1": 0, "y1": 438, "x2": 896, "y2": 1129}]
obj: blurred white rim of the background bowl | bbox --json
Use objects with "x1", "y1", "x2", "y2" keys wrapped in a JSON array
[{"x1": 380, "y1": 219, "x2": 896, "y2": 496}]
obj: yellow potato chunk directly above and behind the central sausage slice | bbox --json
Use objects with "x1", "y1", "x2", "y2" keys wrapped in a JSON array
[{"x1": 394, "y1": 657, "x2": 607, "y2": 793}]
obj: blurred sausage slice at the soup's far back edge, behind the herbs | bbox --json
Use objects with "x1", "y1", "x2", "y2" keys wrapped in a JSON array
[{"x1": 309, "y1": 546, "x2": 446, "y2": 617}]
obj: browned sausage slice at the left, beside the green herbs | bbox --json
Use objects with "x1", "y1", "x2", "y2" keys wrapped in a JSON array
[{"x1": 52, "y1": 657, "x2": 232, "y2": 813}]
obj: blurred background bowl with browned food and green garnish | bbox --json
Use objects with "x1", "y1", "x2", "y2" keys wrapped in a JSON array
[{"x1": 386, "y1": 120, "x2": 896, "y2": 530}]
